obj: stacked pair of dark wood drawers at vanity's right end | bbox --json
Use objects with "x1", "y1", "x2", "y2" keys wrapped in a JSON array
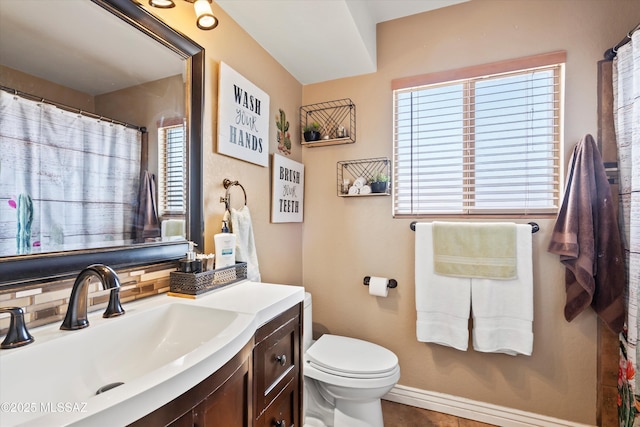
[{"x1": 253, "y1": 305, "x2": 302, "y2": 427}]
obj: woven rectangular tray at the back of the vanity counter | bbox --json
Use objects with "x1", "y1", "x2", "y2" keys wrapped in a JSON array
[{"x1": 168, "y1": 262, "x2": 247, "y2": 298}]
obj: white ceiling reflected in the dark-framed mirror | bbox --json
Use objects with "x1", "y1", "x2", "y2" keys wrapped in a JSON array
[{"x1": 0, "y1": 0, "x2": 185, "y2": 95}]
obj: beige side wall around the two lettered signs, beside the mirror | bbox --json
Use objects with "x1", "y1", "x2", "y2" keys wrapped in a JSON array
[{"x1": 144, "y1": 1, "x2": 306, "y2": 285}]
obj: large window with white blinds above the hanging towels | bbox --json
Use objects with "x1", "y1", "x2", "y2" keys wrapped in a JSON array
[{"x1": 393, "y1": 52, "x2": 566, "y2": 216}]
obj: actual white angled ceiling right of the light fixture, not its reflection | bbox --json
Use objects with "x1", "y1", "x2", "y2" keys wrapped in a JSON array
[{"x1": 214, "y1": 0, "x2": 468, "y2": 84}]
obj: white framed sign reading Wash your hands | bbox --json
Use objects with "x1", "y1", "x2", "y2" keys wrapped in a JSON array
[{"x1": 218, "y1": 62, "x2": 270, "y2": 167}]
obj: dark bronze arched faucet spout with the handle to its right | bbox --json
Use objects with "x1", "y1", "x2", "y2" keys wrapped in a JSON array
[{"x1": 60, "y1": 264, "x2": 124, "y2": 331}]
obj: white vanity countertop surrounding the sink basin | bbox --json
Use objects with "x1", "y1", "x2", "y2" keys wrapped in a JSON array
[{"x1": 0, "y1": 281, "x2": 304, "y2": 427}]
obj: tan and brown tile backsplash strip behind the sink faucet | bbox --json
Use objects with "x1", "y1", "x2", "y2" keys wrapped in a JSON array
[{"x1": 0, "y1": 262, "x2": 177, "y2": 340}]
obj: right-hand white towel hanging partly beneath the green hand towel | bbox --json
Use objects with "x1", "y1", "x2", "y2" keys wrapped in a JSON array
[{"x1": 471, "y1": 224, "x2": 533, "y2": 356}]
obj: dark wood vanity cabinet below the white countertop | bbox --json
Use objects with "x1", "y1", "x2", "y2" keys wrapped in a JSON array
[{"x1": 131, "y1": 304, "x2": 302, "y2": 427}]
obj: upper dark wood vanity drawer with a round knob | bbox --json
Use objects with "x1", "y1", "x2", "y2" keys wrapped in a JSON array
[{"x1": 253, "y1": 306, "x2": 300, "y2": 418}]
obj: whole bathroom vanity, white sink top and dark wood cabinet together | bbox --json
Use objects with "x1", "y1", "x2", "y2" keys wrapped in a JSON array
[{"x1": 0, "y1": 281, "x2": 304, "y2": 427}]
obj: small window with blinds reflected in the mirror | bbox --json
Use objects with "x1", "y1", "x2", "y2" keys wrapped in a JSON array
[{"x1": 158, "y1": 124, "x2": 187, "y2": 216}]
